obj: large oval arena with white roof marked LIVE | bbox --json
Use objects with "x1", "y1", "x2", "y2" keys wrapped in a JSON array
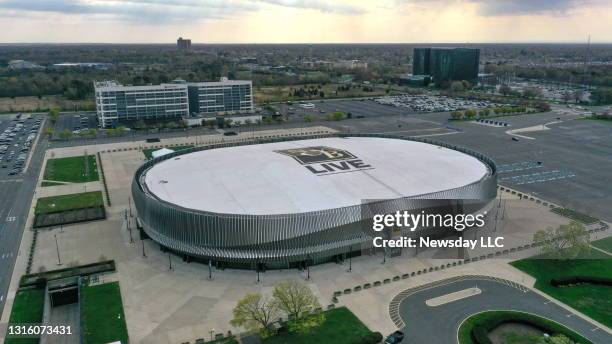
[{"x1": 132, "y1": 134, "x2": 497, "y2": 269}]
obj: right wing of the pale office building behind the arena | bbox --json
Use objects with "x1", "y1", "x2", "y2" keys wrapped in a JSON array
[{"x1": 187, "y1": 78, "x2": 253, "y2": 115}]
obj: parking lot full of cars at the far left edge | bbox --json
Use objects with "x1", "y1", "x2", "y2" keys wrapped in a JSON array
[{"x1": 0, "y1": 115, "x2": 42, "y2": 177}]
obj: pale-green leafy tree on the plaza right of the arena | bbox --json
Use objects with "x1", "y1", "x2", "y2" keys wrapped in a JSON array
[{"x1": 533, "y1": 221, "x2": 591, "y2": 259}]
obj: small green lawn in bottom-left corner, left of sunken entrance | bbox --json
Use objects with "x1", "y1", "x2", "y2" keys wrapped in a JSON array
[{"x1": 5, "y1": 289, "x2": 45, "y2": 344}]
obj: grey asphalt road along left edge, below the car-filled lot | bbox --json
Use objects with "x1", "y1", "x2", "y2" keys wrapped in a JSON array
[{"x1": 0, "y1": 118, "x2": 48, "y2": 320}]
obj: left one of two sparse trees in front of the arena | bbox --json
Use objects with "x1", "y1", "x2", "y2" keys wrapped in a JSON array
[{"x1": 230, "y1": 293, "x2": 280, "y2": 337}]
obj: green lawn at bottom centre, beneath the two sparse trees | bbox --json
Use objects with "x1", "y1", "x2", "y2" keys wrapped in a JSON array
[{"x1": 263, "y1": 307, "x2": 371, "y2": 344}]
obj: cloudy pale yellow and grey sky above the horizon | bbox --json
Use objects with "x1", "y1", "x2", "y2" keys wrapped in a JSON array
[{"x1": 0, "y1": 0, "x2": 612, "y2": 44}]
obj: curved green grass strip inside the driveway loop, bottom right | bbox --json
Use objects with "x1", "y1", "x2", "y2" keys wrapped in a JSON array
[{"x1": 458, "y1": 311, "x2": 591, "y2": 344}]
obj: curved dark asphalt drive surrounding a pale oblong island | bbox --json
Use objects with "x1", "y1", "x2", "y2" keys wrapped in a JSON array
[{"x1": 399, "y1": 279, "x2": 612, "y2": 344}]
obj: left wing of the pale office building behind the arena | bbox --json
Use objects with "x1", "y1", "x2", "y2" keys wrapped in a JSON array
[{"x1": 94, "y1": 81, "x2": 189, "y2": 128}]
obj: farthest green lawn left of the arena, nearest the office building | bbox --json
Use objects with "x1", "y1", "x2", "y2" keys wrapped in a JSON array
[{"x1": 43, "y1": 155, "x2": 100, "y2": 186}]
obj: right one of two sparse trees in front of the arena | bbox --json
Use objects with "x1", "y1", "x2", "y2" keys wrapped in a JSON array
[{"x1": 272, "y1": 281, "x2": 325, "y2": 333}]
